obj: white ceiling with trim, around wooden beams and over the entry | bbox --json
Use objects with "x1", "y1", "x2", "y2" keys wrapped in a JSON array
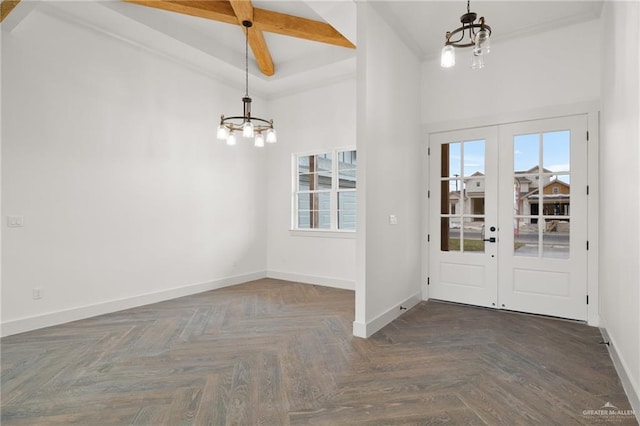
[{"x1": 8, "y1": 0, "x2": 602, "y2": 97}]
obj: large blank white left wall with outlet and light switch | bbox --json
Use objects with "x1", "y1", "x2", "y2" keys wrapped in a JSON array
[{"x1": 1, "y1": 6, "x2": 266, "y2": 335}]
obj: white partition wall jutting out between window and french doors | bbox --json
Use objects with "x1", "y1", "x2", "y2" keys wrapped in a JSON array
[{"x1": 354, "y1": 2, "x2": 423, "y2": 337}]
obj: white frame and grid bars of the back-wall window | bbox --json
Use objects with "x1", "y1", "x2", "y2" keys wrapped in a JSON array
[{"x1": 290, "y1": 146, "x2": 358, "y2": 233}]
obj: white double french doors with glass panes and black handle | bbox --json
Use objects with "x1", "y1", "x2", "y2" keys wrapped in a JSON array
[{"x1": 429, "y1": 115, "x2": 587, "y2": 320}]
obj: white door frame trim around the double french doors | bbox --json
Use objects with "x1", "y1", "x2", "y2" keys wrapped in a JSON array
[{"x1": 422, "y1": 102, "x2": 600, "y2": 327}]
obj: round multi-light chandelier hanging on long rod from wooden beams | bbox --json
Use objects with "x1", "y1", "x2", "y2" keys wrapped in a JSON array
[{"x1": 217, "y1": 21, "x2": 276, "y2": 147}]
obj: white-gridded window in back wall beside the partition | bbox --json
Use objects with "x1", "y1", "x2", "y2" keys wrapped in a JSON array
[{"x1": 293, "y1": 150, "x2": 357, "y2": 231}]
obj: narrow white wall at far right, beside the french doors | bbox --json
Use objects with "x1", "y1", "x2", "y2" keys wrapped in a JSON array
[{"x1": 600, "y1": 1, "x2": 640, "y2": 413}]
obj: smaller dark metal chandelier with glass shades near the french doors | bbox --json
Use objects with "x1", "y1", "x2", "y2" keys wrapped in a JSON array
[{"x1": 440, "y1": 0, "x2": 491, "y2": 69}]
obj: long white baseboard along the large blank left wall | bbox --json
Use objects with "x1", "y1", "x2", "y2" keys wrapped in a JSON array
[{"x1": 0, "y1": 271, "x2": 266, "y2": 337}]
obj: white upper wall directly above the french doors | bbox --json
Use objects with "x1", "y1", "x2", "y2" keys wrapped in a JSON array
[{"x1": 421, "y1": 20, "x2": 601, "y2": 124}]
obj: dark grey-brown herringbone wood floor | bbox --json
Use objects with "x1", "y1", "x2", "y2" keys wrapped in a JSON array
[{"x1": 0, "y1": 279, "x2": 637, "y2": 425}]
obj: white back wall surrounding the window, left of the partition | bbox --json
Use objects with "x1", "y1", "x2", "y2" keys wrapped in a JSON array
[{"x1": 266, "y1": 78, "x2": 356, "y2": 289}]
